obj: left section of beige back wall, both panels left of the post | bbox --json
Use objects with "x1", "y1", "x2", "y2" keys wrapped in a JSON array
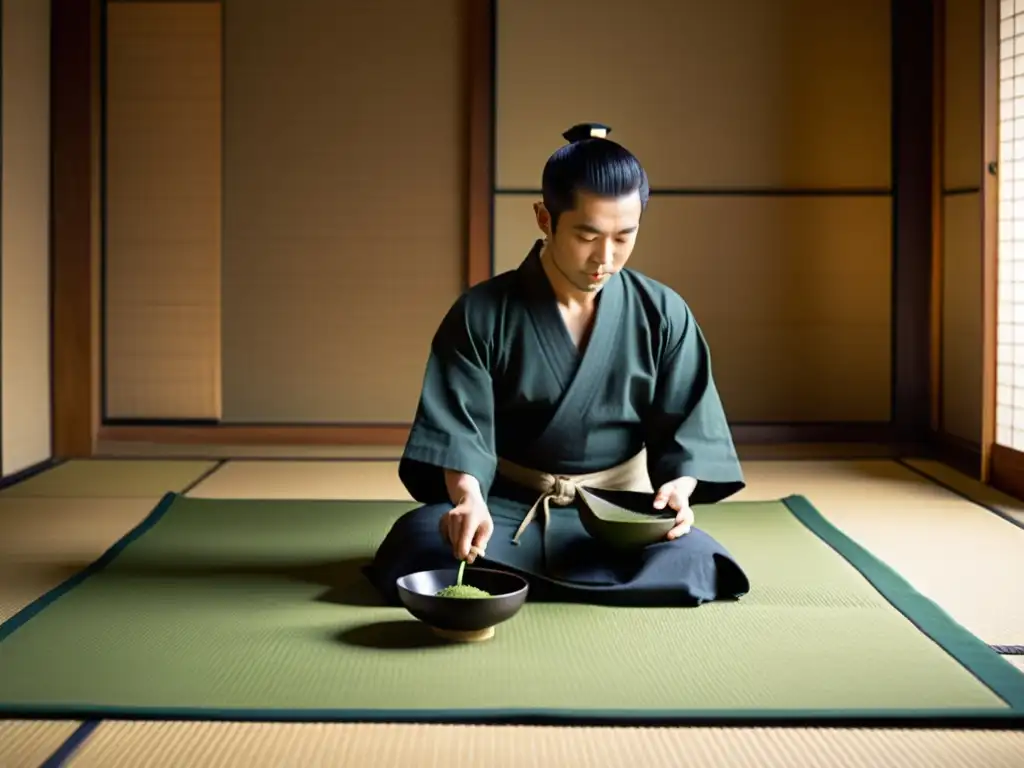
[{"x1": 105, "y1": 0, "x2": 465, "y2": 423}]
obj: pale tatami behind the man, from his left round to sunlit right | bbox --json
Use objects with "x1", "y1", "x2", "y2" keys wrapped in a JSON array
[{"x1": 182, "y1": 460, "x2": 1024, "y2": 645}]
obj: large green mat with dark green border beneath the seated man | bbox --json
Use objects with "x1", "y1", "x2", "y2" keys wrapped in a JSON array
[{"x1": 0, "y1": 494, "x2": 1024, "y2": 727}]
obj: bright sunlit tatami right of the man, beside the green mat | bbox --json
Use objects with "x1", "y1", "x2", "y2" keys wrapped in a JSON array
[{"x1": 733, "y1": 462, "x2": 1024, "y2": 645}]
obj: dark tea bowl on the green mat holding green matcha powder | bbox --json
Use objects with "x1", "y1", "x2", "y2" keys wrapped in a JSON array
[{"x1": 396, "y1": 567, "x2": 529, "y2": 642}]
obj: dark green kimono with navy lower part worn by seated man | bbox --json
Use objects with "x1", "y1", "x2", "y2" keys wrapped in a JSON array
[{"x1": 367, "y1": 243, "x2": 749, "y2": 605}]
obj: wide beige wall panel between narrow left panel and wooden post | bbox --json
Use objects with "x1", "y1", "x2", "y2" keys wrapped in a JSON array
[{"x1": 222, "y1": 0, "x2": 465, "y2": 423}]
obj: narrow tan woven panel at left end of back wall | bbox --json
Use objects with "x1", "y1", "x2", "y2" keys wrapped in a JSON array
[{"x1": 103, "y1": 2, "x2": 222, "y2": 419}]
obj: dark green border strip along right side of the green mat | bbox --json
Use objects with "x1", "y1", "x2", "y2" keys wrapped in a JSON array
[{"x1": 782, "y1": 496, "x2": 1024, "y2": 716}]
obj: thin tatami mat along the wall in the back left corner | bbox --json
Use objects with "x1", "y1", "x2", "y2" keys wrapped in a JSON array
[{"x1": 0, "y1": 459, "x2": 216, "y2": 499}]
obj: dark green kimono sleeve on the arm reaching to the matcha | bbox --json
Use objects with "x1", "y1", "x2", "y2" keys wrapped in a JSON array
[{"x1": 398, "y1": 294, "x2": 497, "y2": 504}]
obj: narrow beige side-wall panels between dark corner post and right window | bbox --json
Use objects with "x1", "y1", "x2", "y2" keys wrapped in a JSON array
[{"x1": 941, "y1": 0, "x2": 984, "y2": 443}]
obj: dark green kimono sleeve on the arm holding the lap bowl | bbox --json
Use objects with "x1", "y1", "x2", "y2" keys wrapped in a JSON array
[{"x1": 644, "y1": 299, "x2": 745, "y2": 504}]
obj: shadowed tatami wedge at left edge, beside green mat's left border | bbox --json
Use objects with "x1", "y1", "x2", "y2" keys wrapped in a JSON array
[{"x1": 0, "y1": 497, "x2": 160, "y2": 626}]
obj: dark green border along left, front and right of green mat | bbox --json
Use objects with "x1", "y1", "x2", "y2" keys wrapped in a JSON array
[{"x1": 0, "y1": 493, "x2": 1024, "y2": 729}]
